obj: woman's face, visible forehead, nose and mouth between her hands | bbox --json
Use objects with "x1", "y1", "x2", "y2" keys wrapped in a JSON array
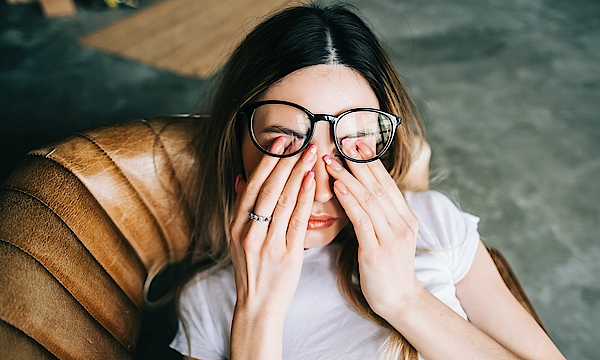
[{"x1": 242, "y1": 65, "x2": 379, "y2": 248}]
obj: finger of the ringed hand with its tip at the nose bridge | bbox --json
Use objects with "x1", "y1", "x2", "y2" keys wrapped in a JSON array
[{"x1": 268, "y1": 144, "x2": 317, "y2": 239}]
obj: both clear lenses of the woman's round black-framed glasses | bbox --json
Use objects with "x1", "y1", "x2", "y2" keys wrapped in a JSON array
[{"x1": 252, "y1": 104, "x2": 393, "y2": 160}]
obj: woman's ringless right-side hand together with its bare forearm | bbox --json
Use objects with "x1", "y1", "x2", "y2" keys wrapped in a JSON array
[{"x1": 324, "y1": 142, "x2": 560, "y2": 360}]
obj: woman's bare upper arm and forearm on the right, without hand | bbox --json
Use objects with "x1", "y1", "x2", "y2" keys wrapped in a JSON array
[{"x1": 382, "y1": 242, "x2": 564, "y2": 359}]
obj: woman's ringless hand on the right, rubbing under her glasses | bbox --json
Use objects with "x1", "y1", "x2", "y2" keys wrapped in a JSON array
[{"x1": 323, "y1": 142, "x2": 423, "y2": 319}]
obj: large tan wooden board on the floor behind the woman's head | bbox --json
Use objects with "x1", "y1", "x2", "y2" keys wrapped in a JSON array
[{"x1": 81, "y1": 0, "x2": 289, "y2": 78}]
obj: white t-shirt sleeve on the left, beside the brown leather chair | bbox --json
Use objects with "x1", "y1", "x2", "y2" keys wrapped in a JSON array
[{"x1": 170, "y1": 279, "x2": 227, "y2": 360}]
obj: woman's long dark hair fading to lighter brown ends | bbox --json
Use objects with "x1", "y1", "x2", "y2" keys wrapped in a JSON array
[{"x1": 183, "y1": 4, "x2": 423, "y2": 359}]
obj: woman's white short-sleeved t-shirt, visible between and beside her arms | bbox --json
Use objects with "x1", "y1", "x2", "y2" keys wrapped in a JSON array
[{"x1": 171, "y1": 191, "x2": 479, "y2": 360}]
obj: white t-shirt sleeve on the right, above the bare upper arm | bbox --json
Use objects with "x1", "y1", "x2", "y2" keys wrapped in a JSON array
[{"x1": 408, "y1": 191, "x2": 480, "y2": 284}]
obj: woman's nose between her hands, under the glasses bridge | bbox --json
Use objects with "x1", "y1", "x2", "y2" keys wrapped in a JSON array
[{"x1": 312, "y1": 123, "x2": 336, "y2": 203}]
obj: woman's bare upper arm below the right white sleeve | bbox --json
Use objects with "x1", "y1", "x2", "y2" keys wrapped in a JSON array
[{"x1": 456, "y1": 242, "x2": 564, "y2": 359}]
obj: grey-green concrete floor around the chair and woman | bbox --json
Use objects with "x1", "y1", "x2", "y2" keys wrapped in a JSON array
[{"x1": 0, "y1": 0, "x2": 600, "y2": 359}]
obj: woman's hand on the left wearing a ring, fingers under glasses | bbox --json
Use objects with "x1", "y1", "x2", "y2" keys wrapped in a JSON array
[{"x1": 230, "y1": 138, "x2": 317, "y2": 325}]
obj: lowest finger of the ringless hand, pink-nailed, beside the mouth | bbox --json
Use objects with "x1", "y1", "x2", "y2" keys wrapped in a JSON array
[{"x1": 333, "y1": 180, "x2": 379, "y2": 253}]
